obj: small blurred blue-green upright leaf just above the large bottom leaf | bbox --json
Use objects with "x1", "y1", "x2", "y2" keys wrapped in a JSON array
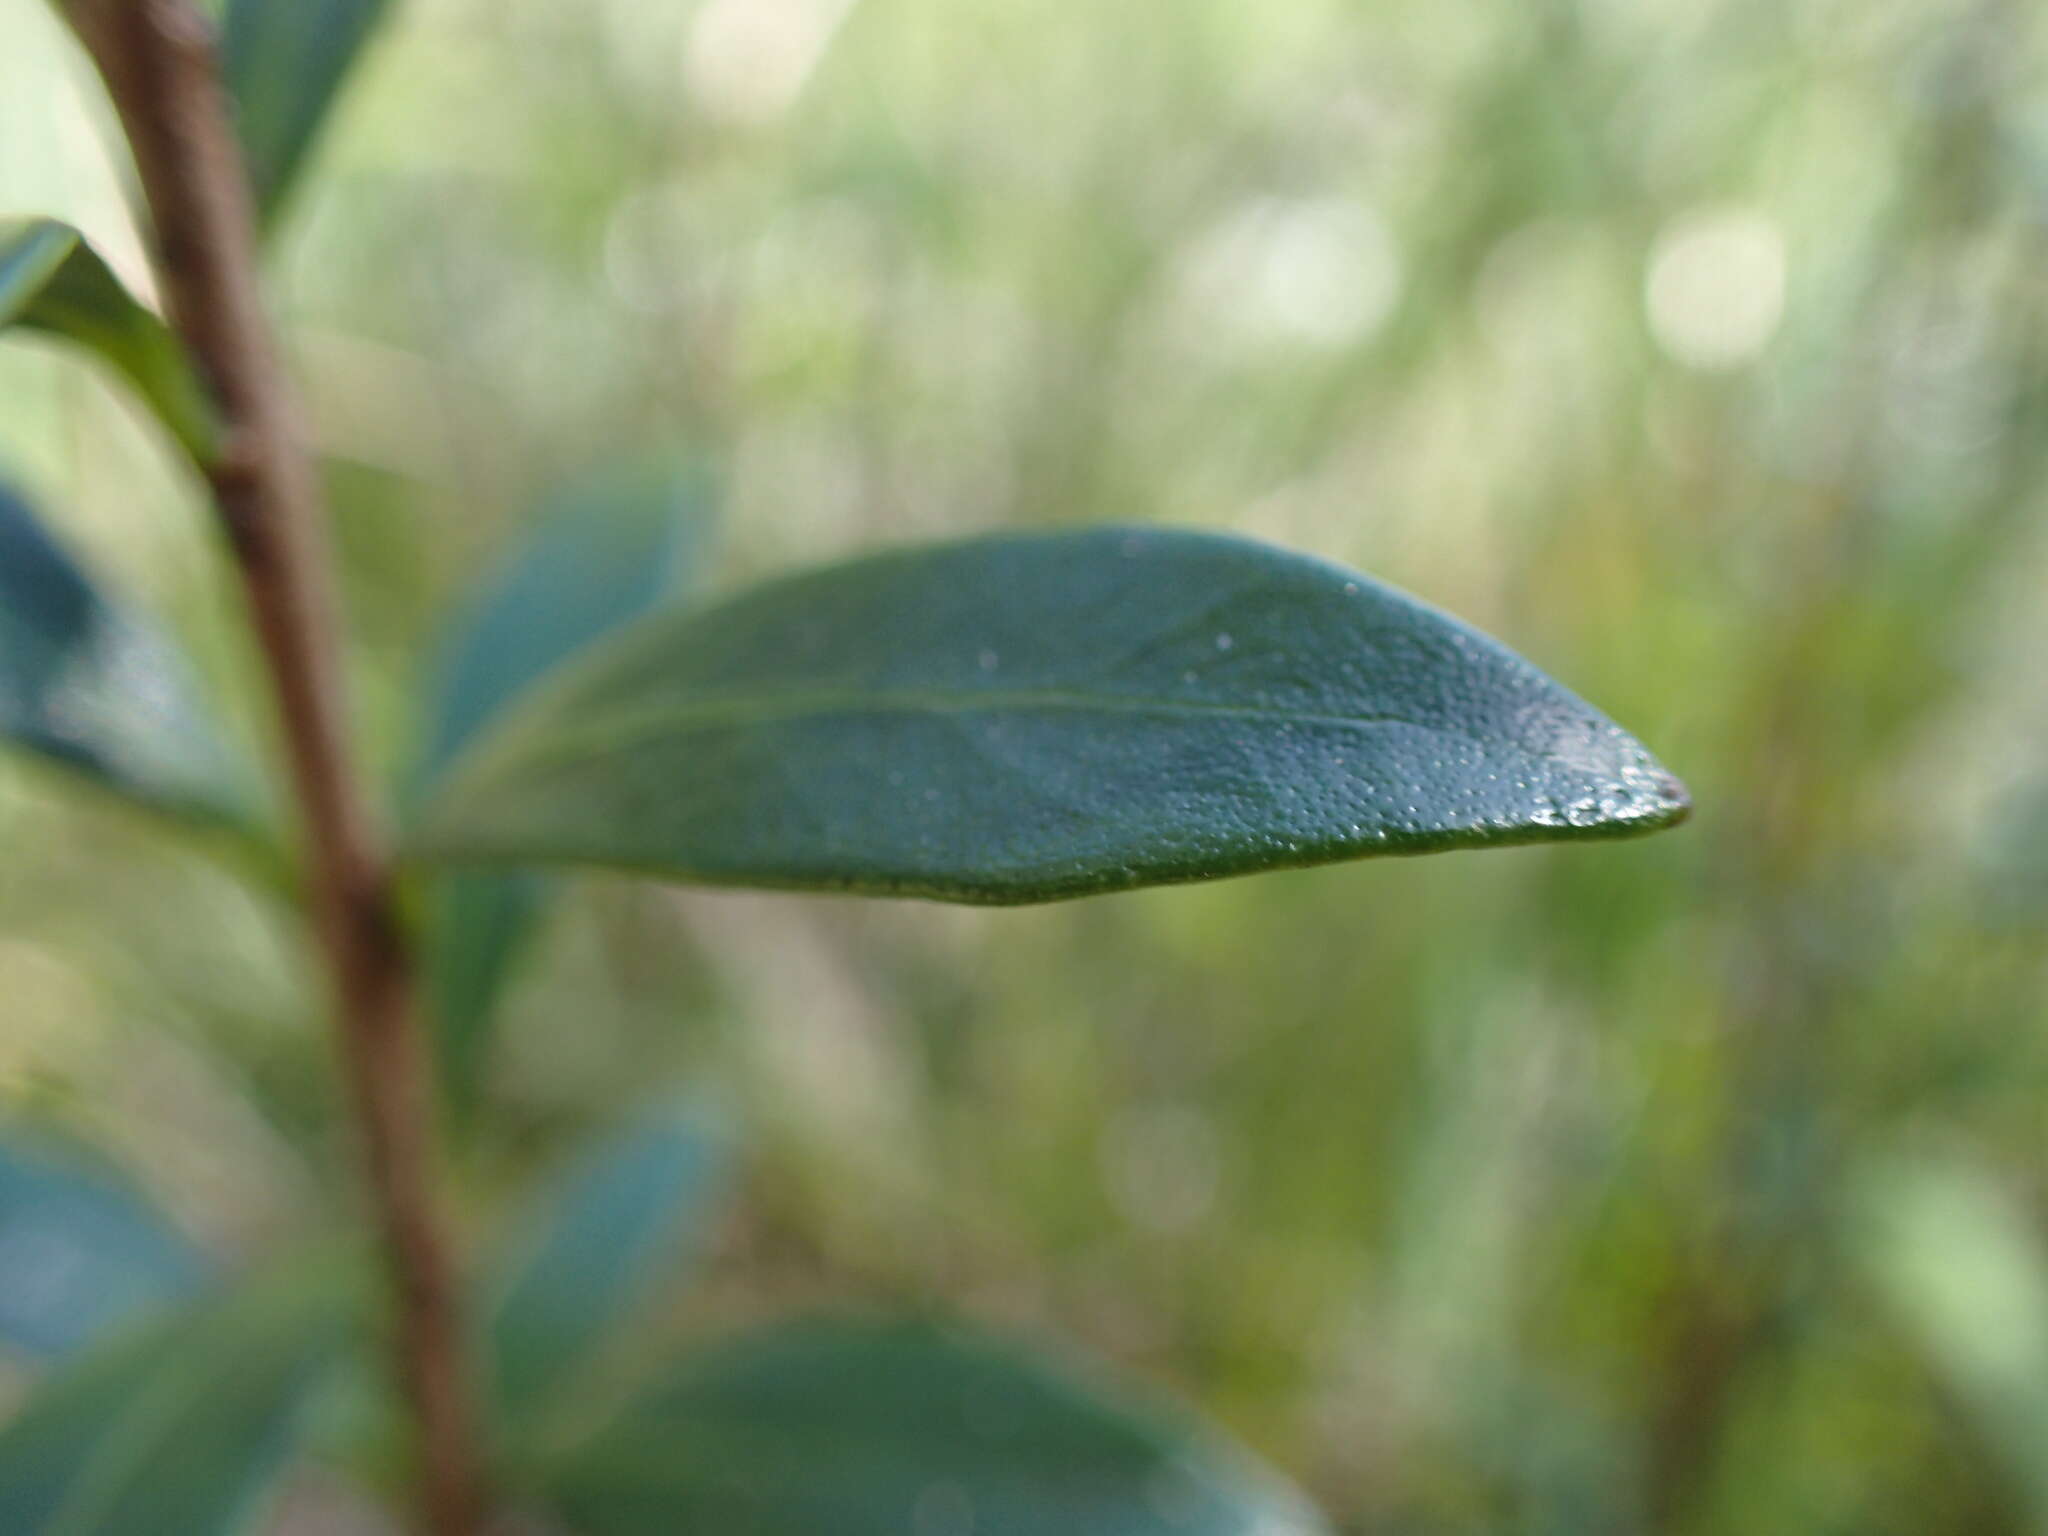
[{"x1": 489, "y1": 1106, "x2": 725, "y2": 1419}]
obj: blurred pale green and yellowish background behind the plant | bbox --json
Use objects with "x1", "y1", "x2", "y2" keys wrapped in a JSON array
[{"x1": 0, "y1": 0, "x2": 2048, "y2": 1536}]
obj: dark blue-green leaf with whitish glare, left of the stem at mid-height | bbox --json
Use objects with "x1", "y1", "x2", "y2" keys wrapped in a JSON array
[{"x1": 0, "y1": 483, "x2": 262, "y2": 843}]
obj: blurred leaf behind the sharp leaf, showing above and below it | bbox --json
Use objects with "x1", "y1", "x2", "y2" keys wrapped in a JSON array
[{"x1": 420, "y1": 467, "x2": 709, "y2": 1106}]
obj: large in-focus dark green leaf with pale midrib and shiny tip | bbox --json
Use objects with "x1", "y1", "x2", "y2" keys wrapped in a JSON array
[{"x1": 414, "y1": 528, "x2": 1688, "y2": 901}]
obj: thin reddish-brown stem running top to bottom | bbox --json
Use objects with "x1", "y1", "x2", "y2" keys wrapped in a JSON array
[{"x1": 61, "y1": 0, "x2": 483, "y2": 1536}]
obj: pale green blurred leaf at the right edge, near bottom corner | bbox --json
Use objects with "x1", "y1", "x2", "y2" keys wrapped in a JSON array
[{"x1": 1853, "y1": 1161, "x2": 2048, "y2": 1528}]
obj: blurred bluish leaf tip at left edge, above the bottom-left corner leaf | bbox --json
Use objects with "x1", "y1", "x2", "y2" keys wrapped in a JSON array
[{"x1": 0, "y1": 1145, "x2": 205, "y2": 1358}]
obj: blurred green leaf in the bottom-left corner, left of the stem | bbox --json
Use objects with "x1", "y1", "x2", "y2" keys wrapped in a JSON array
[{"x1": 0, "y1": 1286, "x2": 340, "y2": 1536}]
